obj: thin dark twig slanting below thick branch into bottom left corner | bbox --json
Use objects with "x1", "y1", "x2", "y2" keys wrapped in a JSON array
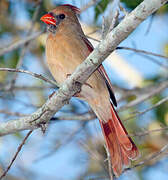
[{"x1": 0, "y1": 130, "x2": 33, "y2": 179}]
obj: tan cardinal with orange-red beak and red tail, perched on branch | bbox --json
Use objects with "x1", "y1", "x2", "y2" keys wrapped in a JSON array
[{"x1": 41, "y1": 4, "x2": 139, "y2": 176}]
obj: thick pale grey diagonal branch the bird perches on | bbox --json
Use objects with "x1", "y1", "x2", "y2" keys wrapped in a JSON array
[{"x1": 0, "y1": 0, "x2": 168, "y2": 136}]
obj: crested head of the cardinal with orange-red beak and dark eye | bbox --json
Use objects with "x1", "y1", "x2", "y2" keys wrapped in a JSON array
[{"x1": 40, "y1": 4, "x2": 80, "y2": 32}]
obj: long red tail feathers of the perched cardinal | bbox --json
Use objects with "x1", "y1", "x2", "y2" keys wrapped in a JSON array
[{"x1": 100, "y1": 105, "x2": 139, "y2": 176}]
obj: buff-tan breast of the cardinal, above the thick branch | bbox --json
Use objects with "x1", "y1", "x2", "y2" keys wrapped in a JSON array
[{"x1": 46, "y1": 33, "x2": 88, "y2": 84}]
